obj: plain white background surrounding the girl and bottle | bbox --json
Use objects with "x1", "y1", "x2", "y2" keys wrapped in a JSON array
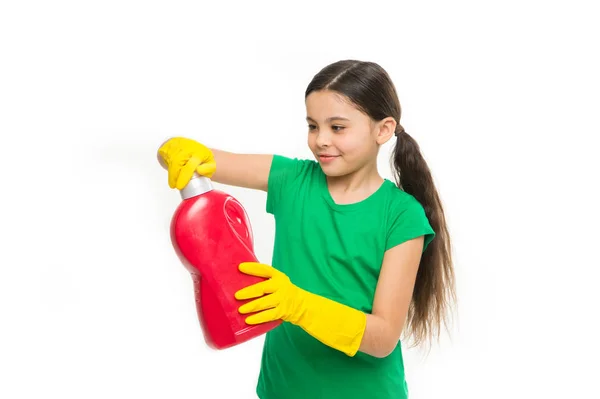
[{"x1": 0, "y1": 0, "x2": 600, "y2": 399}]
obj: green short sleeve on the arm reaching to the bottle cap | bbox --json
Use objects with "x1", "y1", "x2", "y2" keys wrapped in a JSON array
[{"x1": 266, "y1": 155, "x2": 310, "y2": 215}]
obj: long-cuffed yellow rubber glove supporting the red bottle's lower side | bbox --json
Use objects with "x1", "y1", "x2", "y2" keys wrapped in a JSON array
[{"x1": 235, "y1": 262, "x2": 367, "y2": 356}]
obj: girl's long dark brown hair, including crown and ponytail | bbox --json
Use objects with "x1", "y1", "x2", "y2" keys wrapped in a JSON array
[{"x1": 305, "y1": 60, "x2": 456, "y2": 345}]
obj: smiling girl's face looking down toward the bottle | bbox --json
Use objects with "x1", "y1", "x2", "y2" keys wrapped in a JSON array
[{"x1": 306, "y1": 91, "x2": 395, "y2": 176}]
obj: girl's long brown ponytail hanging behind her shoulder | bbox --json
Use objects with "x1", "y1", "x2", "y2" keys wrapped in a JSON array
[{"x1": 392, "y1": 124, "x2": 456, "y2": 346}]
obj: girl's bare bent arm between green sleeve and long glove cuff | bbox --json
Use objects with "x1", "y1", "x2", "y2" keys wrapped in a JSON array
[{"x1": 359, "y1": 236, "x2": 423, "y2": 357}]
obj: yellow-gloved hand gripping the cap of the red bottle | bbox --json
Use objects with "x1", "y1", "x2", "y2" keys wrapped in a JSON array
[{"x1": 158, "y1": 137, "x2": 217, "y2": 190}]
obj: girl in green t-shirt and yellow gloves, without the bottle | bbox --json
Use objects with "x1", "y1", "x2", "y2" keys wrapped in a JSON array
[{"x1": 159, "y1": 60, "x2": 455, "y2": 399}]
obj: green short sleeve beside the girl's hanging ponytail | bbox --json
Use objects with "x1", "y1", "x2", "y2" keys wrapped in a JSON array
[{"x1": 385, "y1": 199, "x2": 435, "y2": 252}]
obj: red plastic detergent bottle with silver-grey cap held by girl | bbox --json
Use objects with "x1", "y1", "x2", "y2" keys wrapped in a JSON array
[{"x1": 171, "y1": 174, "x2": 281, "y2": 349}]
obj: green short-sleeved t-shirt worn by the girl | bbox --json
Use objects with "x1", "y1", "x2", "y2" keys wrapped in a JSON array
[{"x1": 257, "y1": 155, "x2": 434, "y2": 399}]
